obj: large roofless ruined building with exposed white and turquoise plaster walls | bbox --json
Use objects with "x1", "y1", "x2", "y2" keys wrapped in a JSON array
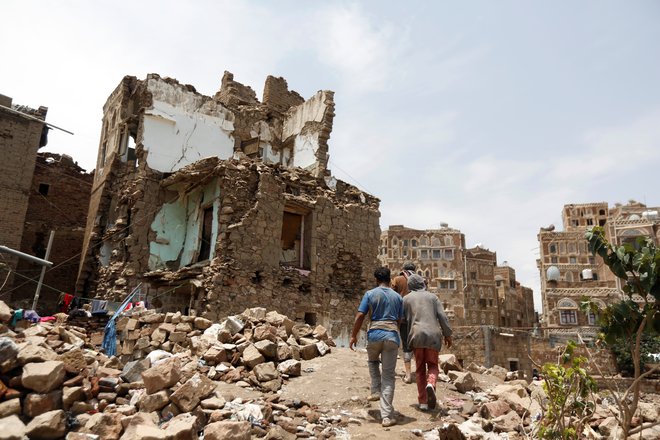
[{"x1": 77, "y1": 72, "x2": 380, "y2": 341}]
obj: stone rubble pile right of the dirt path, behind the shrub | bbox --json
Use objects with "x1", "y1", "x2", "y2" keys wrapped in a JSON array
[{"x1": 419, "y1": 354, "x2": 660, "y2": 440}]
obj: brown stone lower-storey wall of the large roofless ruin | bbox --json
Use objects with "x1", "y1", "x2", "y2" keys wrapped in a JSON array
[{"x1": 87, "y1": 159, "x2": 379, "y2": 343}]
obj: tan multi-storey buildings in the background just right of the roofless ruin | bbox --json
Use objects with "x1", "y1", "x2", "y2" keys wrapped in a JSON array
[{"x1": 378, "y1": 224, "x2": 535, "y2": 327}]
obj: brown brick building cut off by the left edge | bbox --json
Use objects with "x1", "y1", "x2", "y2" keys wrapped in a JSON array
[{"x1": 0, "y1": 95, "x2": 48, "y2": 296}]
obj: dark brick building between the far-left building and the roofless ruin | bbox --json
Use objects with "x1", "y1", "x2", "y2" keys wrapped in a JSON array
[{"x1": 11, "y1": 153, "x2": 93, "y2": 313}]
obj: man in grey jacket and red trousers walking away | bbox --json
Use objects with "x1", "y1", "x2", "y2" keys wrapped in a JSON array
[{"x1": 403, "y1": 275, "x2": 452, "y2": 411}]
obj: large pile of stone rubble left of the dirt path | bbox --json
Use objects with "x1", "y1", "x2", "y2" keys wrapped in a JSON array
[{"x1": 0, "y1": 304, "x2": 348, "y2": 440}]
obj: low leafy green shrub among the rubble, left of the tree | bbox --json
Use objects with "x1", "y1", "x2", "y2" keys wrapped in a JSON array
[{"x1": 538, "y1": 341, "x2": 597, "y2": 440}]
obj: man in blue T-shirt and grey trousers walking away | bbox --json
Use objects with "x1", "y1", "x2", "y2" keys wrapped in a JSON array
[{"x1": 348, "y1": 267, "x2": 403, "y2": 427}]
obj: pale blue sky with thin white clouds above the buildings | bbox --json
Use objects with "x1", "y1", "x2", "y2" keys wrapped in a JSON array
[{"x1": 0, "y1": 0, "x2": 660, "y2": 310}]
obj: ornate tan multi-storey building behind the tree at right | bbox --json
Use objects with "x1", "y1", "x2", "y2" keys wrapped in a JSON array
[{"x1": 537, "y1": 201, "x2": 660, "y2": 340}]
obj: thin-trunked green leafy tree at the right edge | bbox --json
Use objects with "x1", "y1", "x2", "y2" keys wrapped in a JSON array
[{"x1": 586, "y1": 227, "x2": 660, "y2": 438}]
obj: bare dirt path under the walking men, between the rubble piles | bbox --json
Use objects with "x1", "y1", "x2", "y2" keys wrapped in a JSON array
[{"x1": 282, "y1": 348, "x2": 469, "y2": 439}]
